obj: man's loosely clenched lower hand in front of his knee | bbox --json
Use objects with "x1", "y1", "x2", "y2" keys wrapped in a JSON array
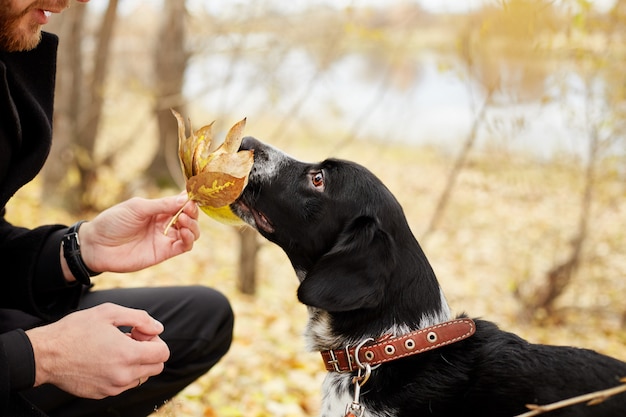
[{"x1": 26, "y1": 303, "x2": 169, "y2": 399}]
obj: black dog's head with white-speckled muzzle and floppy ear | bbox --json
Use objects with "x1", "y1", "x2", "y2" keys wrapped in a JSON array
[{"x1": 231, "y1": 137, "x2": 436, "y2": 312}]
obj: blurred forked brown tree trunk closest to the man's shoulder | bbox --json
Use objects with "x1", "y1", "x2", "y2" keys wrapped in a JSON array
[{"x1": 42, "y1": 0, "x2": 118, "y2": 212}]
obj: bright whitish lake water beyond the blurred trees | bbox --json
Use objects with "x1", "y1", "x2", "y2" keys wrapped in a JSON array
[{"x1": 185, "y1": 50, "x2": 623, "y2": 158}]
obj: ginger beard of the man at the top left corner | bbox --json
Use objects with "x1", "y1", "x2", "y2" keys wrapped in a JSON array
[{"x1": 0, "y1": 0, "x2": 69, "y2": 52}]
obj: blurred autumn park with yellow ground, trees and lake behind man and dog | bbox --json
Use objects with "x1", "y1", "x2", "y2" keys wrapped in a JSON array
[{"x1": 8, "y1": 0, "x2": 626, "y2": 417}]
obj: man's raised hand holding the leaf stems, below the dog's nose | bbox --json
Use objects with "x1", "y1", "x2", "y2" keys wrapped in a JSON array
[{"x1": 73, "y1": 193, "x2": 200, "y2": 272}]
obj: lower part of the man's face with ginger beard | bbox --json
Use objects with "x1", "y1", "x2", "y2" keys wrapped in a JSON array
[{"x1": 0, "y1": 0, "x2": 70, "y2": 51}]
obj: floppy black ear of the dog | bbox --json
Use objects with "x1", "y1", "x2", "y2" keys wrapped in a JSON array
[{"x1": 298, "y1": 216, "x2": 395, "y2": 312}]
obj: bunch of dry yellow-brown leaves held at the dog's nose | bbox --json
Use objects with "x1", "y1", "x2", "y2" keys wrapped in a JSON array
[{"x1": 164, "y1": 110, "x2": 254, "y2": 234}]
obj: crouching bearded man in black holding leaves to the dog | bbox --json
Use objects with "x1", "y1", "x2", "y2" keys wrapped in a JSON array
[{"x1": 0, "y1": 0, "x2": 233, "y2": 417}]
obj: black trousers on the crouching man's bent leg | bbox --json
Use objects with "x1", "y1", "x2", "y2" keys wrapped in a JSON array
[{"x1": 16, "y1": 286, "x2": 234, "y2": 417}]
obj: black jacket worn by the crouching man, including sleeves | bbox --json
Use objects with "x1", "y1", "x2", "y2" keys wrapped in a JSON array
[{"x1": 0, "y1": 33, "x2": 82, "y2": 416}]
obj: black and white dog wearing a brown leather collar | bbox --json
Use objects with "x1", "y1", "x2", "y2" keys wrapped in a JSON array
[{"x1": 231, "y1": 137, "x2": 626, "y2": 417}]
